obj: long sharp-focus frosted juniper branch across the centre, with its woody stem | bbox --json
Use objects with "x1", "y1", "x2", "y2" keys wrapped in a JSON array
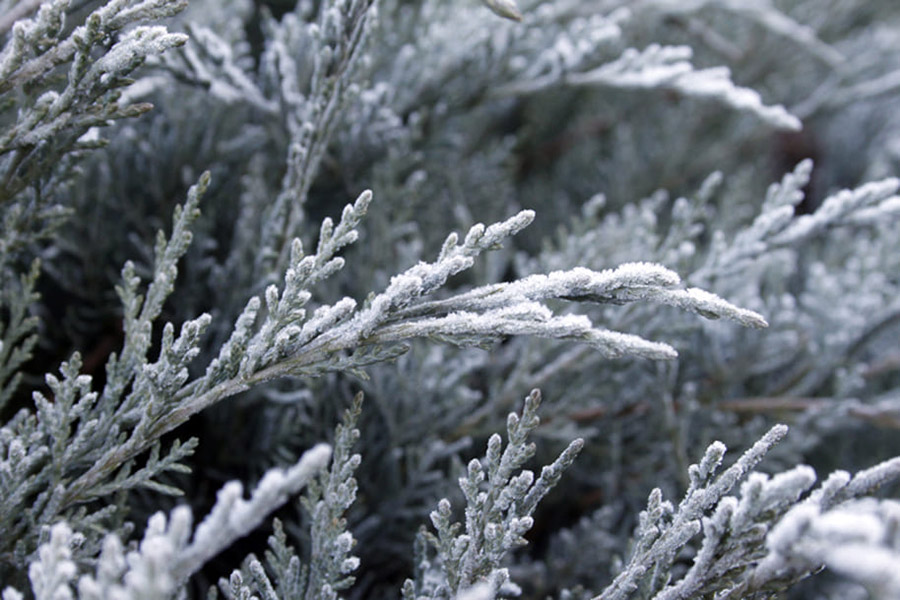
[{"x1": 61, "y1": 192, "x2": 765, "y2": 516}]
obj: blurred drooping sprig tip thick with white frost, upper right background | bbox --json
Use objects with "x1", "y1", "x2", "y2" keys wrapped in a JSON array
[{"x1": 496, "y1": 44, "x2": 801, "y2": 130}]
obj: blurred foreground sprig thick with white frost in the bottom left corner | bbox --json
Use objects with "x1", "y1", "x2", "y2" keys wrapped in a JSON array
[{"x1": 3, "y1": 444, "x2": 331, "y2": 600}]
